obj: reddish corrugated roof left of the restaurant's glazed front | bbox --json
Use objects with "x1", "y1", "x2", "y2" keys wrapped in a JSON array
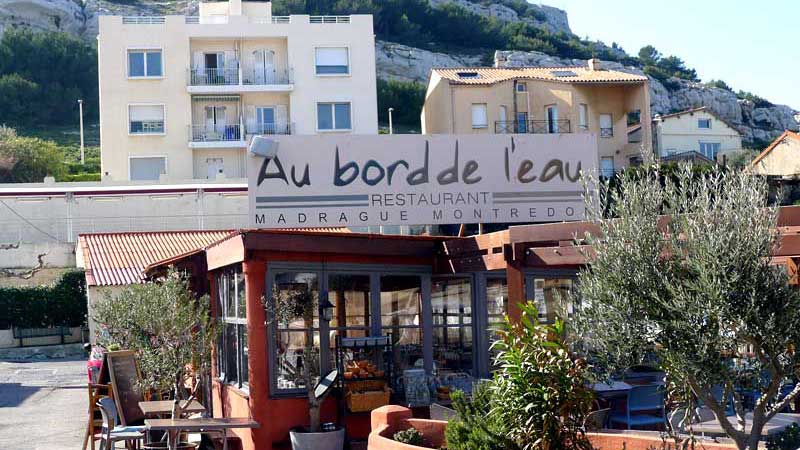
[{"x1": 77, "y1": 230, "x2": 233, "y2": 286}]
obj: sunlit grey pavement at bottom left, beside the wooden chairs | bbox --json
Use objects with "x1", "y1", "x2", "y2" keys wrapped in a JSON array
[{"x1": 0, "y1": 358, "x2": 87, "y2": 450}]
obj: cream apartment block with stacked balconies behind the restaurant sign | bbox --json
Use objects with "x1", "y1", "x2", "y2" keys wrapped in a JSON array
[{"x1": 98, "y1": 0, "x2": 378, "y2": 181}]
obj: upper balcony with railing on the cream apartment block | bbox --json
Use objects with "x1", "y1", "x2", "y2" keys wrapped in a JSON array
[{"x1": 187, "y1": 67, "x2": 294, "y2": 94}]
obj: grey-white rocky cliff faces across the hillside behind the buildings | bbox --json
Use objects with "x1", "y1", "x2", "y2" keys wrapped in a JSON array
[{"x1": 0, "y1": 0, "x2": 800, "y2": 143}]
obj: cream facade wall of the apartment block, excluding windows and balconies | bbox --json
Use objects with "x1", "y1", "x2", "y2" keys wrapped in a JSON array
[{"x1": 98, "y1": 1, "x2": 378, "y2": 180}]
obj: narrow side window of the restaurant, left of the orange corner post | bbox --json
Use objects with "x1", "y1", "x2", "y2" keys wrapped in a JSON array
[{"x1": 216, "y1": 266, "x2": 248, "y2": 387}]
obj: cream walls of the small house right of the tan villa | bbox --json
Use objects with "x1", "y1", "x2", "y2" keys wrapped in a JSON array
[{"x1": 654, "y1": 111, "x2": 742, "y2": 158}]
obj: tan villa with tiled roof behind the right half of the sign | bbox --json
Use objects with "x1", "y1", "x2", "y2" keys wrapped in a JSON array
[{"x1": 422, "y1": 60, "x2": 651, "y2": 174}]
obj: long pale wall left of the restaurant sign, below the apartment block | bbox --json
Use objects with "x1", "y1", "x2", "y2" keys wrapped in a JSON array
[{"x1": 0, "y1": 180, "x2": 247, "y2": 244}]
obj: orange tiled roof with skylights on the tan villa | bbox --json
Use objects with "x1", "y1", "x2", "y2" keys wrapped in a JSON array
[{"x1": 433, "y1": 67, "x2": 647, "y2": 85}]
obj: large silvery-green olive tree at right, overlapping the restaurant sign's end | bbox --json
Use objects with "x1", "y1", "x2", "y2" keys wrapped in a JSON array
[{"x1": 574, "y1": 164, "x2": 800, "y2": 450}]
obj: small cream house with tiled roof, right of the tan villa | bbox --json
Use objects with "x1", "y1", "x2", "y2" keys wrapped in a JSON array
[{"x1": 653, "y1": 106, "x2": 742, "y2": 161}]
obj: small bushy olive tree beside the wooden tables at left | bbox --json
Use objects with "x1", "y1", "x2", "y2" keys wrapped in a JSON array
[{"x1": 94, "y1": 271, "x2": 216, "y2": 449}]
